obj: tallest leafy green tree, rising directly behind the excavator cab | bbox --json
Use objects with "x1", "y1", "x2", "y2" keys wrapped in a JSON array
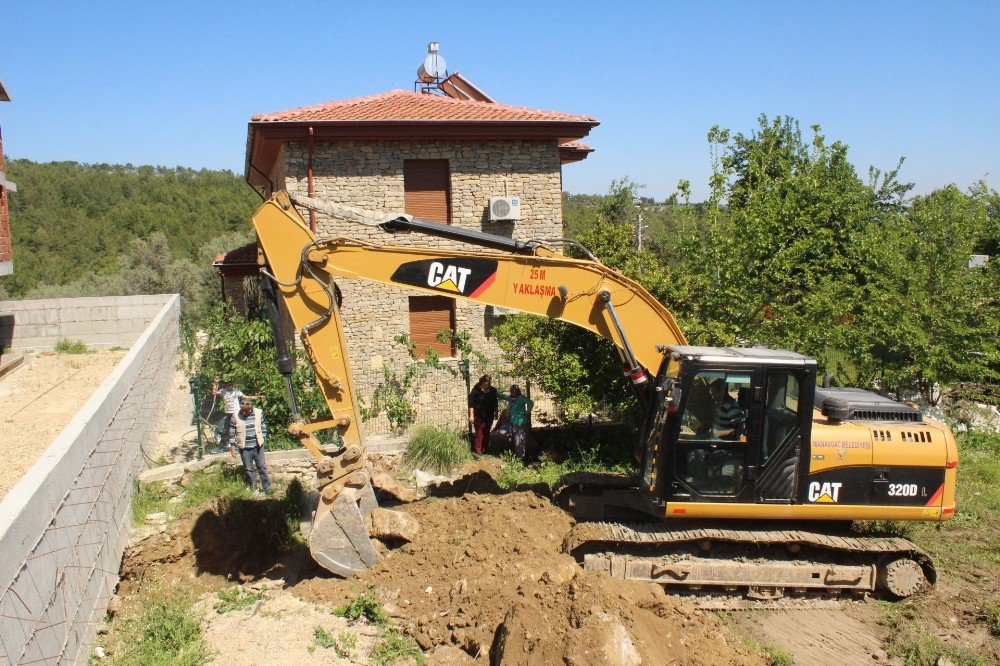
[{"x1": 665, "y1": 116, "x2": 907, "y2": 356}]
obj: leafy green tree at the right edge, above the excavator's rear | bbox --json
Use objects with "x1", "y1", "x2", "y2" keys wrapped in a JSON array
[{"x1": 844, "y1": 183, "x2": 1000, "y2": 402}]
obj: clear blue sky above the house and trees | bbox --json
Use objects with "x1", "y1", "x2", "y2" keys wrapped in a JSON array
[{"x1": 0, "y1": 0, "x2": 1000, "y2": 199}]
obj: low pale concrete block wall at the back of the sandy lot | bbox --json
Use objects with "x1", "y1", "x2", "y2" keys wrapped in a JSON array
[{"x1": 0, "y1": 294, "x2": 174, "y2": 351}]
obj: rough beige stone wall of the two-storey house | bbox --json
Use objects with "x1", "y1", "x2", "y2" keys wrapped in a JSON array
[{"x1": 271, "y1": 141, "x2": 563, "y2": 434}]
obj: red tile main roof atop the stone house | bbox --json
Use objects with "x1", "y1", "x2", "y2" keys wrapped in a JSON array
[{"x1": 252, "y1": 90, "x2": 597, "y2": 124}]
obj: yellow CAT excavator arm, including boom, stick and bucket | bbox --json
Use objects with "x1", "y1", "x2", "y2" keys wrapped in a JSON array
[{"x1": 253, "y1": 192, "x2": 685, "y2": 576}]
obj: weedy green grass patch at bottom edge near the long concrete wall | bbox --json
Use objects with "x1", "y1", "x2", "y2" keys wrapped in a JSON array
[{"x1": 101, "y1": 587, "x2": 209, "y2": 666}]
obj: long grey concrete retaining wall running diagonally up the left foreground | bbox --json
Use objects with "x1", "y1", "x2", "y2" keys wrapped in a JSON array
[{"x1": 0, "y1": 295, "x2": 180, "y2": 664}]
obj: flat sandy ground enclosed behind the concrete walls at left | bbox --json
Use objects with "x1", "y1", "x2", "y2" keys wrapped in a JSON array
[{"x1": 0, "y1": 350, "x2": 126, "y2": 497}]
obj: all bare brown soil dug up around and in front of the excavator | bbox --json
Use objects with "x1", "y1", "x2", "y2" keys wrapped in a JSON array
[{"x1": 120, "y1": 457, "x2": 1000, "y2": 665}]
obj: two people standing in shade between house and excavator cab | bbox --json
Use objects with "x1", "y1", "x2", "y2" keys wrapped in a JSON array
[{"x1": 469, "y1": 375, "x2": 536, "y2": 461}]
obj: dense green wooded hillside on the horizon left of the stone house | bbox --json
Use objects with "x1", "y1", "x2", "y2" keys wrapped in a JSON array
[{"x1": 0, "y1": 159, "x2": 260, "y2": 298}]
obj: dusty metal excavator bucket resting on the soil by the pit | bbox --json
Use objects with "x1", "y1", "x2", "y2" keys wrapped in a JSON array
[{"x1": 309, "y1": 482, "x2": 381, "y2": 578}]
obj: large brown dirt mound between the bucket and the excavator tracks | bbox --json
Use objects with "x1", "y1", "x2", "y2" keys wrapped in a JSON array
[{"x1": 294, "y1": 477, "x2": 764, "y2": 666}]
